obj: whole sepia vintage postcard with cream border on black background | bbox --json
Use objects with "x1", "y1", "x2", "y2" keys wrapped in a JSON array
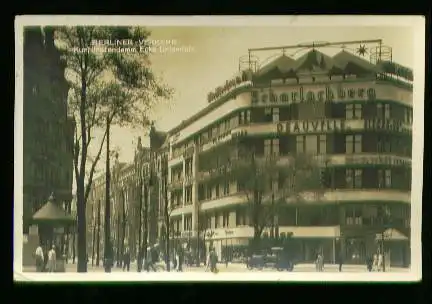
[{"x1": 14, "y1": 16, "x2": 425, "y2": 282}]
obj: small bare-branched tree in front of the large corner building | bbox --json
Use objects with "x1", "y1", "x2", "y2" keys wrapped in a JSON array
[{"x1": 234, "y1": 147, "x2": 322, "y2": 251}]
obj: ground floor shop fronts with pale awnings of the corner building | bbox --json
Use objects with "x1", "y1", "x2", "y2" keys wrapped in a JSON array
[{"x1": 201, "y1": 226, "x2": 410, "y2": 267}]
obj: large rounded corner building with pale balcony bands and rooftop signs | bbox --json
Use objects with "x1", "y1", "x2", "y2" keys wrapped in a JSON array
[{"x1": 168, "y1": 44, "x2": 413, "y2": 265}]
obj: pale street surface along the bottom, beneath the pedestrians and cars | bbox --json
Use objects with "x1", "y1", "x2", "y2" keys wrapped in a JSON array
[{"x1": 23, "y1": 263, "x2": 409, "y2": 273}]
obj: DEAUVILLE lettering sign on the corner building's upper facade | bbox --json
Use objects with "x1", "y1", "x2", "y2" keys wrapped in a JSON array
[{"x1": 277, "y1": 119, "x2": 345, "y2": 133}]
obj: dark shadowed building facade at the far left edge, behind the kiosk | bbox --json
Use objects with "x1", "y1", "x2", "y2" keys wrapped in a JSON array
[{"x1": 23, "y1": 27, "x2": 75, "y2": 234}]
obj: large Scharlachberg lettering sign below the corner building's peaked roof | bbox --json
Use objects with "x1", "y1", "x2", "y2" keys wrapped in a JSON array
[{"x1": 252, "y1": 85, "x2": 376, "y2": 104}]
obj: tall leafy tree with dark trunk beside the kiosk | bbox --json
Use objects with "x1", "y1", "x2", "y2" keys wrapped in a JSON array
[{"x1": 56, "y1": 26, "x2": 171, "y2": 272}]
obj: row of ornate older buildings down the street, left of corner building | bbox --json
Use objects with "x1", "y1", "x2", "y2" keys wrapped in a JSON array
[{"x1": 87, "y1": 128, "x2": 165, "y2": 260}]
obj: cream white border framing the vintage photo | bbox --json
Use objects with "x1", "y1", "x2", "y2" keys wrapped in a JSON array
[{"x1": 13, "y1": 15, "x2": 425, "y2": 282}]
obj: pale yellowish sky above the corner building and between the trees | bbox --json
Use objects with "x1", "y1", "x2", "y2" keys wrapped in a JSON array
[{"x1": 85, "y1": 26, "x2": 414, "y2": 185}]
